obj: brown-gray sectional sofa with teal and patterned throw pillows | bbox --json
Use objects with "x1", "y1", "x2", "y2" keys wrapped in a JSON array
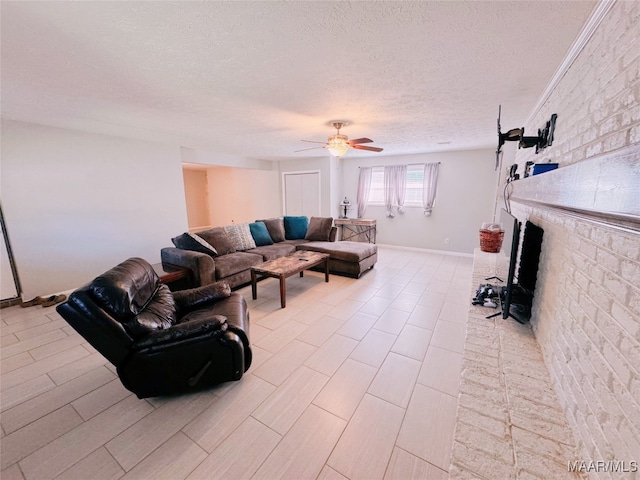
[{"x1": 160, "y1": 216, "x2": 378, "y2": 288}]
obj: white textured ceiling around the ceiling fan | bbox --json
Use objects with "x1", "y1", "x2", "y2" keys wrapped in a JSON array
[{"x1": 0, "y1": 0, "x2": 596, "y2": 160}]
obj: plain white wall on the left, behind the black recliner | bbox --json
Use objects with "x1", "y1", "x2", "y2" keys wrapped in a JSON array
[{"x1": 1, "y1": 121, "x2": 187, "y2": 299}]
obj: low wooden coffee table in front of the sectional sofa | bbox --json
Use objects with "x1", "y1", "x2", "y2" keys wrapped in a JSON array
[{"x1": 251, "y1": 251, "x2": 329, "y2": 308}]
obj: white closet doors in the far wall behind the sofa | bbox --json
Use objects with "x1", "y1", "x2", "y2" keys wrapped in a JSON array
[{"x1": 283, "y1": 172, "x2": 320, "y2": 217}]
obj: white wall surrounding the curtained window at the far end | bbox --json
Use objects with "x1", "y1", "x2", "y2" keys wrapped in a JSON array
[{"x1": 341, "y1": 150, "x2": 497, "y2": 254}]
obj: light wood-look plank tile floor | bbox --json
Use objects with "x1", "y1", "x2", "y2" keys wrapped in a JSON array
[{"x1": 0, "y1": 247, "x2": 473, "y2": 480}]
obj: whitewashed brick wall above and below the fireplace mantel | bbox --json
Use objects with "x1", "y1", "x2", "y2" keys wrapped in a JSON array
[{"x1": 498, "y1": 0, "x2": 640, "y2": 472}]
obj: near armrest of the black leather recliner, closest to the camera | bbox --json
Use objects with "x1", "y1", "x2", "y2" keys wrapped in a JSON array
[{"x1": 132, "y1": 315, "x2": 228, "y2": 350}]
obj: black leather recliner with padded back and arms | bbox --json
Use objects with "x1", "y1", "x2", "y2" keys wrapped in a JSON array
[{"x1": 56, "y1": 258, "x2": 251, "y2": 398}]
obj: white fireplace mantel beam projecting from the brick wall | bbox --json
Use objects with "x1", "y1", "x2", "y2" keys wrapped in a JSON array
[{"x1": 509, "y1": 145, "x2": 640, "y2": 234}]
